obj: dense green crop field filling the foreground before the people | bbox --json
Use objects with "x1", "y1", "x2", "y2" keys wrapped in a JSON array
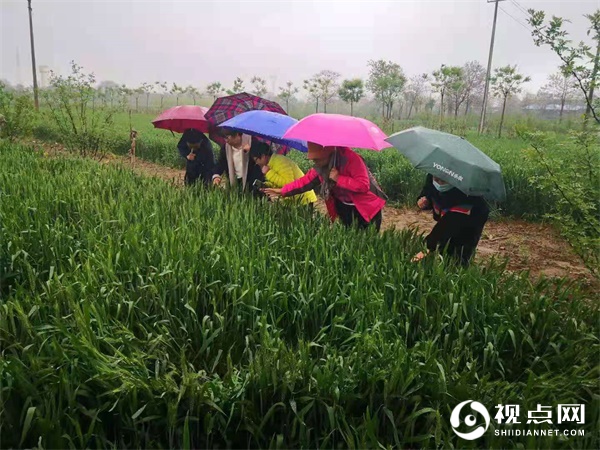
[{"x1": 0, "y1": 144, "x2": 600, "y2": 448}]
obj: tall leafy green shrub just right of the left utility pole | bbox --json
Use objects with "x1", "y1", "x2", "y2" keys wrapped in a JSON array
[{"x1": 42, "y1": 63, "x2": 124, "y2": 156}]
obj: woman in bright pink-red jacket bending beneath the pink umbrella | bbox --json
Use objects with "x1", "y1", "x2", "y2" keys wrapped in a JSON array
[{"x1": 263, "y1": 142, "x2": 385, "y2": 231}]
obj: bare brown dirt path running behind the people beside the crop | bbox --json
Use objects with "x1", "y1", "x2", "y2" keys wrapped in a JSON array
[{"x1": 27, "y1": 141, "x2": 599, "y2": 288}]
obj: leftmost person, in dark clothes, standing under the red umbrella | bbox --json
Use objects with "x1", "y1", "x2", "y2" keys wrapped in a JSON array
[{"x1": 177, "y1": 128, "x2": 215, "y2": 186}]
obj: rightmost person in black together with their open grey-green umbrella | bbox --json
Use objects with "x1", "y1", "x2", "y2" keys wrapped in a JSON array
[{"x1": 386, "y1": 127, "x2": 506, "y2": 266}]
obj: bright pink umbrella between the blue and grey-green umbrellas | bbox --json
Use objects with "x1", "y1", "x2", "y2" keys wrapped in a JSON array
[{"x1": 283, "y1": 114, "x2": 391, "y2": 151}]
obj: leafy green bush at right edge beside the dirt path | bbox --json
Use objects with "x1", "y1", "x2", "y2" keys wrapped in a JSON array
[{"x1": 519, "y1": 129, "x2": 600, "y2": 276}]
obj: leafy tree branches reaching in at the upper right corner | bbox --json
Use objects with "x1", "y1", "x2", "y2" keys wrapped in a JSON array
[{"x1": 528, "y1": 9, "x2": 600, "y2": 123}]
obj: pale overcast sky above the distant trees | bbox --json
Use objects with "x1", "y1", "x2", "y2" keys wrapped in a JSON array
[{"x1": 0, "y1": 0, "x2": 600, "y2": 91}]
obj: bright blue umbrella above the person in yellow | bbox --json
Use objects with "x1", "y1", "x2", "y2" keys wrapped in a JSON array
[{"x1": 220, "y1": 110, "x2": 308, "y2": 152}]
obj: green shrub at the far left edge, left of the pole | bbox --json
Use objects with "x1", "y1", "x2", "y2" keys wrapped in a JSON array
[{"x1": 0, "y1": 83, "x2": 34, "y2": 140}]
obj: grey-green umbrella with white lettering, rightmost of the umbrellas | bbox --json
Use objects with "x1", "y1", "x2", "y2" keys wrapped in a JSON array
[{"x1": 386, "y1": 127, "x2": 506, "y2": 201}]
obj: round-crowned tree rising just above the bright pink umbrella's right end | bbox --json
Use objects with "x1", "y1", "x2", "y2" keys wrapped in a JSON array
[{"x1": 367, "y1": 59, "x2": 406, "y2": 119}]
